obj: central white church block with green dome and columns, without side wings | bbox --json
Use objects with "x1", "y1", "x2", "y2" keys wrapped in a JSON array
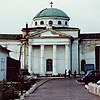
[{"x1": 22, "y1": 7, "x2": 80, "y2": 76}]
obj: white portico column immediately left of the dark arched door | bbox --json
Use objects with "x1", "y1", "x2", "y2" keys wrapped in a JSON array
[{"x1": 40, "y1": 45, "x2": 45, "y2": 76}]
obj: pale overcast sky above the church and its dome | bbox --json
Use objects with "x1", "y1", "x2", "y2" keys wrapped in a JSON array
[{"x1": 0, "y1": 0, "x2": 100, "y2": 33}]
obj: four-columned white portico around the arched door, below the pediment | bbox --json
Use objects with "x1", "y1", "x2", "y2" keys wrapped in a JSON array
[{"x1": 28, "y1": 39, "x2": 70, "y2": 76}]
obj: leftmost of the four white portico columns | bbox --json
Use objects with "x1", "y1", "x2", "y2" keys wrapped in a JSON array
[{"x1": 28, "y1": 45, "x2": 32, "y2": 74}]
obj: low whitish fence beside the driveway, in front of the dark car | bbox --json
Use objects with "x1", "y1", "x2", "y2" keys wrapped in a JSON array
[{"x1": 85, "y1": 83, "x2": 100, "y2": 96}]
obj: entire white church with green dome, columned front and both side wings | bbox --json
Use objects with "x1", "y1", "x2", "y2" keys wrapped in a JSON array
[{"x1": 0, "y1": 7, "x2": 100, "y2": 76}]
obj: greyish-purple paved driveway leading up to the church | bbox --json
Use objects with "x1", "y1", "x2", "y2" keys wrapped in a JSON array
[{"x1": 24, "y1": 78, "x2": 100, "y2": 100}]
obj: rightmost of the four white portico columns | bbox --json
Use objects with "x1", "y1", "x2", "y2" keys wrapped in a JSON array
[{"x1": 65, "y1": 44, "x2": 70, "y2": 74}]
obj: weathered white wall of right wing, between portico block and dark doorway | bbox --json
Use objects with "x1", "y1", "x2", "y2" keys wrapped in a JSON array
[{"x1": 80, "y1": 40, "x2": 96, "y2": 70}]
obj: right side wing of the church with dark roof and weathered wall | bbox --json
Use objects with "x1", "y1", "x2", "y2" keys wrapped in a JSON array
[{"x1": 79, "y1": 33, "x2": 100, "y2": 71}]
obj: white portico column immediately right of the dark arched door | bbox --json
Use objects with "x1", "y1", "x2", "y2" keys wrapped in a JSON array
[{"x1": 53, "y1": 45, "x2": 57, "y2": 75}]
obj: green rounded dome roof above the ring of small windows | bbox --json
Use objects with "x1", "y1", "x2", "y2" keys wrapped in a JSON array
[{"x1": 34, "y1": 8, "x2": 70, "y2": 20}]
